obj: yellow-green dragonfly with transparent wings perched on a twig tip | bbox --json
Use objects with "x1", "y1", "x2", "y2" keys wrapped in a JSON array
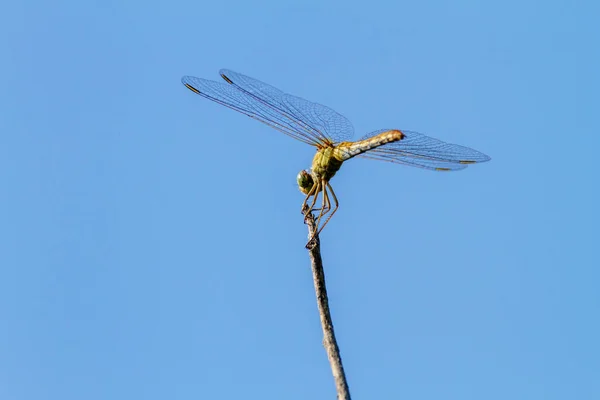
[{"x1": 181, "y1": 69, "x2": 491, "y2": 248}]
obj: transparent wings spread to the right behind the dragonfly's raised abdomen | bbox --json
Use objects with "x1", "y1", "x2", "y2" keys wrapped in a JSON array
[{"x1": 358, "y1": 129, "x2": 490, "y2": 171}]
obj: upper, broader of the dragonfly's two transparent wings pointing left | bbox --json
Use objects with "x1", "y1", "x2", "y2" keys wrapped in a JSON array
[{"x1": 219, "y1": 69, "x2": 354, "y2": 143}]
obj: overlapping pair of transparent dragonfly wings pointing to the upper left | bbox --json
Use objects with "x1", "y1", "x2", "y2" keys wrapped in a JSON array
[{"x1": 181, "y1": 70, "x2": 354, "y2": 146}]
